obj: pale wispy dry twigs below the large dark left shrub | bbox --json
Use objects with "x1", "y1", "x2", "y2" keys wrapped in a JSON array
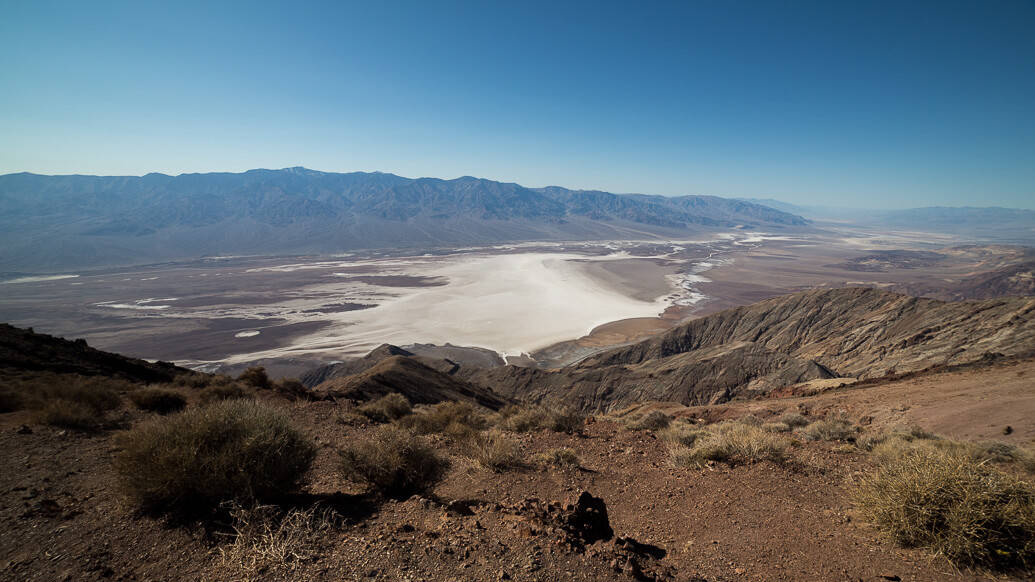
[{"x1": 216, "y1": 505, "x2": 338, "y2": 582}]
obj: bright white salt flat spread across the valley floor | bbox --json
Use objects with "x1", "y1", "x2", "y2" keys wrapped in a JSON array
[{"x1": 215, "y1": 253, "x2": 668, "y2": 363}]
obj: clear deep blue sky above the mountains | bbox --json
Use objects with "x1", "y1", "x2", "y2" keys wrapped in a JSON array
[{"x1": 0, "y1": 0, "x2": 1035, "y2": 208}]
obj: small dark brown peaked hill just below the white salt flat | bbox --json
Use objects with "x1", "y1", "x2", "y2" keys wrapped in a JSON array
[{"x1": 314, "y1": 355, "x2": 510, "y2": 410}]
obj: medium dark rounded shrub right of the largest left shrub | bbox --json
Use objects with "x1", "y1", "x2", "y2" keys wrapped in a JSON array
[{"x1": 341, "y1": 416, "x2": 449, "y2": 496}]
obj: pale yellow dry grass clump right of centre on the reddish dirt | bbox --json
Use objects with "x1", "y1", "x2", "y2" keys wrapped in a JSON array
[{"x1": 672, "y1": 421, "x2": 791, "y2": 466}]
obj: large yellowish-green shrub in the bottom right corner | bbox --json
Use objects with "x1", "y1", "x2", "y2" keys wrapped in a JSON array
[{"x1": 856, "y1": 446, "x2": 1035, "y2": 569}]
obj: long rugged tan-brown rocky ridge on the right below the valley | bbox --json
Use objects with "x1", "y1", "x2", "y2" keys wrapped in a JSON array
[{"x1": 461, "y1": 288, "x2": 1035, "y2": 411}]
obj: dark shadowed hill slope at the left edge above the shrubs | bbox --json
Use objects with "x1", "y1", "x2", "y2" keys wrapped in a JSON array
[{"x1": 0, "y1": 323, "x2": 189, "y2": 382}]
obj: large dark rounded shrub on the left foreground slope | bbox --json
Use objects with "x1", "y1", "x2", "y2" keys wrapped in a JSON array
[{"x1": 116, "y1": 400, "x2": 316, "y2": 510}]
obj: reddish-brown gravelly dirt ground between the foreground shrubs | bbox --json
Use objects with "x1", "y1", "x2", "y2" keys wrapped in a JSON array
[{"x1": 0, "y1": 361, "x2": 1035, "y2": 581}]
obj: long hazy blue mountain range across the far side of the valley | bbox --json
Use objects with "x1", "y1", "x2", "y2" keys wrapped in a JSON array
[{"x1": 0, "y1": 168, "x2": 808, "y2": 272}]
